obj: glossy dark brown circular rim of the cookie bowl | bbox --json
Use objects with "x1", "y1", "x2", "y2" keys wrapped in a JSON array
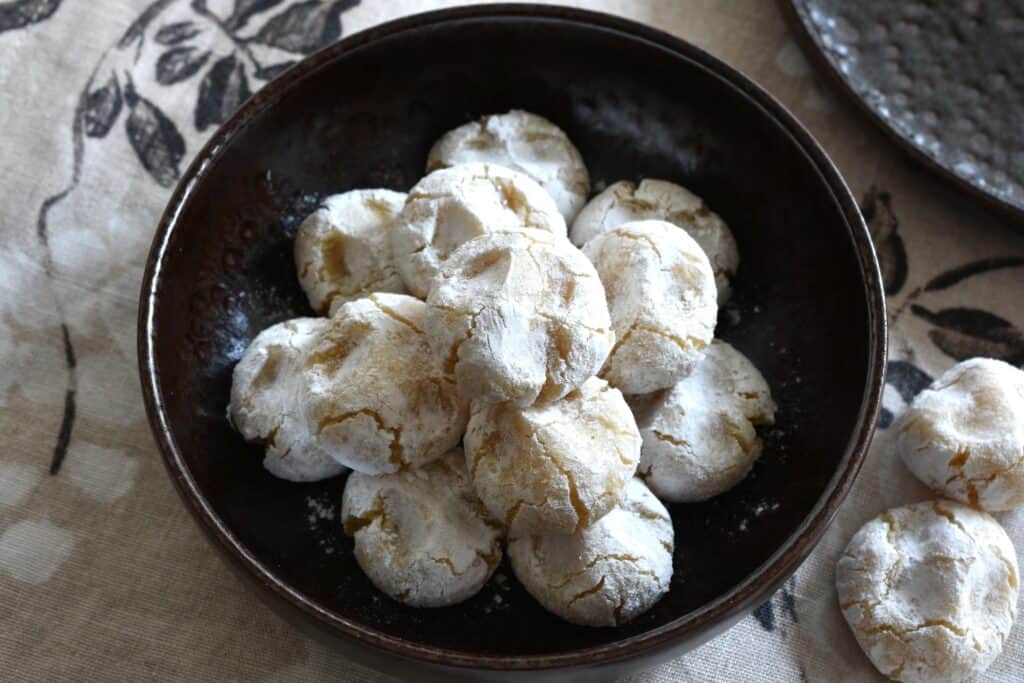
[{"x1": 137, "y1": 3, "x2": 887, "y2": 671}]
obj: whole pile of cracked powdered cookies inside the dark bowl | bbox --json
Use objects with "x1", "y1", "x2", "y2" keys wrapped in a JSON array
[{"x1": 228, "y1": 111, "x2": 775, "y2": 626}]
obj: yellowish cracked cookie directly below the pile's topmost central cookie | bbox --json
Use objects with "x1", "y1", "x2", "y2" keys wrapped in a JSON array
[{"x1": 464, "y1": 377, "x2": 640, "y2": 535}]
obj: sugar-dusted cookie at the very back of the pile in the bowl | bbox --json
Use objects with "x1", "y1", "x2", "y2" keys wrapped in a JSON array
[{"x1": 427, "y1": 110, "x2": 590, "y2": 221}]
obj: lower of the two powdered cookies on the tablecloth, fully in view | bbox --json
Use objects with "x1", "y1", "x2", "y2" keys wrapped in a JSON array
[{"x1": 836, "y1": 501, "x2": 1019, "y2": 683}]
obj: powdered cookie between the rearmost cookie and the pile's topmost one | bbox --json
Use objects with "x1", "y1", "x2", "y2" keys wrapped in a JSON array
[{"x1": 391, "y1": 164, "x2": 565, "y2": 299}]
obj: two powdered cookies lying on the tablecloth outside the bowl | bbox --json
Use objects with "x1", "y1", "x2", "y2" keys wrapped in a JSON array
[{"x1": 836, "y1": 358, "x2": 1024, "y2": 681}]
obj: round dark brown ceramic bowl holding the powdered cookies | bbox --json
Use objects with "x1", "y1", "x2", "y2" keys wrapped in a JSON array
[{"x1": 138, "y1": 5, "x2": 886, "y2": 678}]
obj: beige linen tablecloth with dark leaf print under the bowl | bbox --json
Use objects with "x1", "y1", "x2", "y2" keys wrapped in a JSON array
[{"x1": 0, "y1": 0, "x2": 1024, "y2": 683}]
